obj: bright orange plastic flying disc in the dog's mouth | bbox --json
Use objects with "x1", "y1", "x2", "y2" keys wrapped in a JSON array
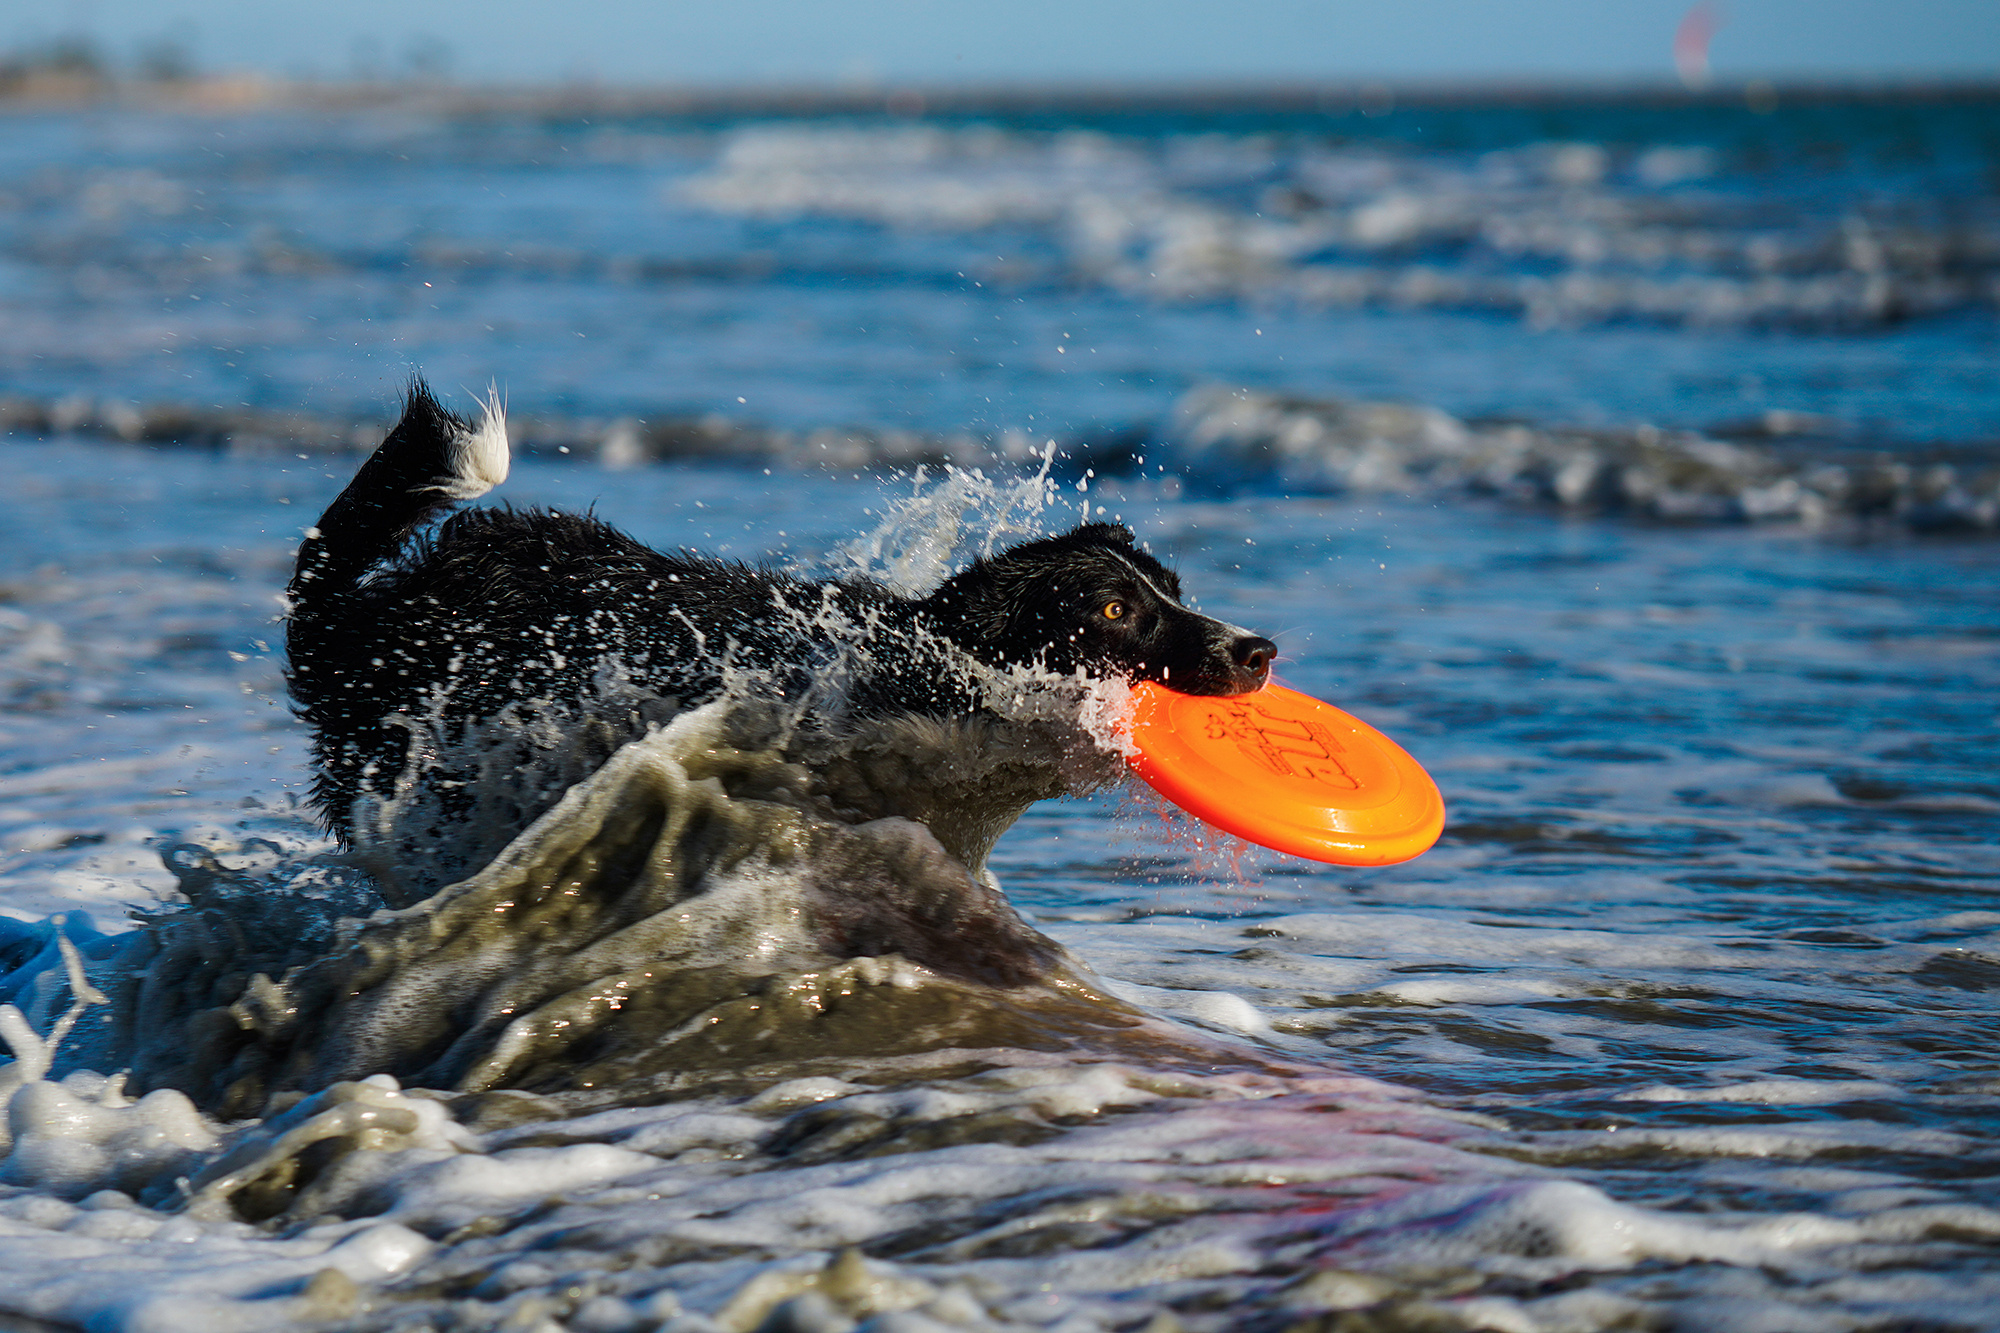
[{"x1": 1128, "y1": 681, "x2": 1444, "y2": 865}]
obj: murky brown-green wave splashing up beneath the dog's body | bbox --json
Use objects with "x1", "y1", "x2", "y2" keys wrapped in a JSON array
[{"x1": 96, "y1": 705, "x2": 1164, "y2": 1117}]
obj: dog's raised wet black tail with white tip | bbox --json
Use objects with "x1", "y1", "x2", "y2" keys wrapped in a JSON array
[{"x1": 288, "y1": 378, "x2": 508, "y2": 616}]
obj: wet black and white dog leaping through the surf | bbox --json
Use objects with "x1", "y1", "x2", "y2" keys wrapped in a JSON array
[{"x1": 286, "y1": 380, "x2": 1276, "y2": 888}]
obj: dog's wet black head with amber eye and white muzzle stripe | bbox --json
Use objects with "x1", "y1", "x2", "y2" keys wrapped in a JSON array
[{"x1": 924, "y1": 522, "x2": 1278, "y2": 695}]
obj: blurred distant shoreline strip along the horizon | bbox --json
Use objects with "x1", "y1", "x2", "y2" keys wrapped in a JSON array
[{"x1": 0, "y1": 68, "x2": 2000, "y2": 118}]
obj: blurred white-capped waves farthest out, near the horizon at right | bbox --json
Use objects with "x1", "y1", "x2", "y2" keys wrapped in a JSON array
[{"x1": 682, "y1": 124, "x2": 2000, "y2": 328}]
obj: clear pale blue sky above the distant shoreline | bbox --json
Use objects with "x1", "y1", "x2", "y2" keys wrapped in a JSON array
[{"x1": 19, "y1": 0, "x2": 2000, "y2": 84}]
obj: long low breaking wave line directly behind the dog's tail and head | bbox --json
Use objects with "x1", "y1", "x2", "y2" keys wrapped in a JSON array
[{"x1": 11, "y1": 386, "x2": 2000, "y2": 528}]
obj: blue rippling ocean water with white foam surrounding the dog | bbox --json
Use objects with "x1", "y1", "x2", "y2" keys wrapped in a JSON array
[{"x1": 0, "y1": 93, "x2": 2000, "y2": 1333}]
